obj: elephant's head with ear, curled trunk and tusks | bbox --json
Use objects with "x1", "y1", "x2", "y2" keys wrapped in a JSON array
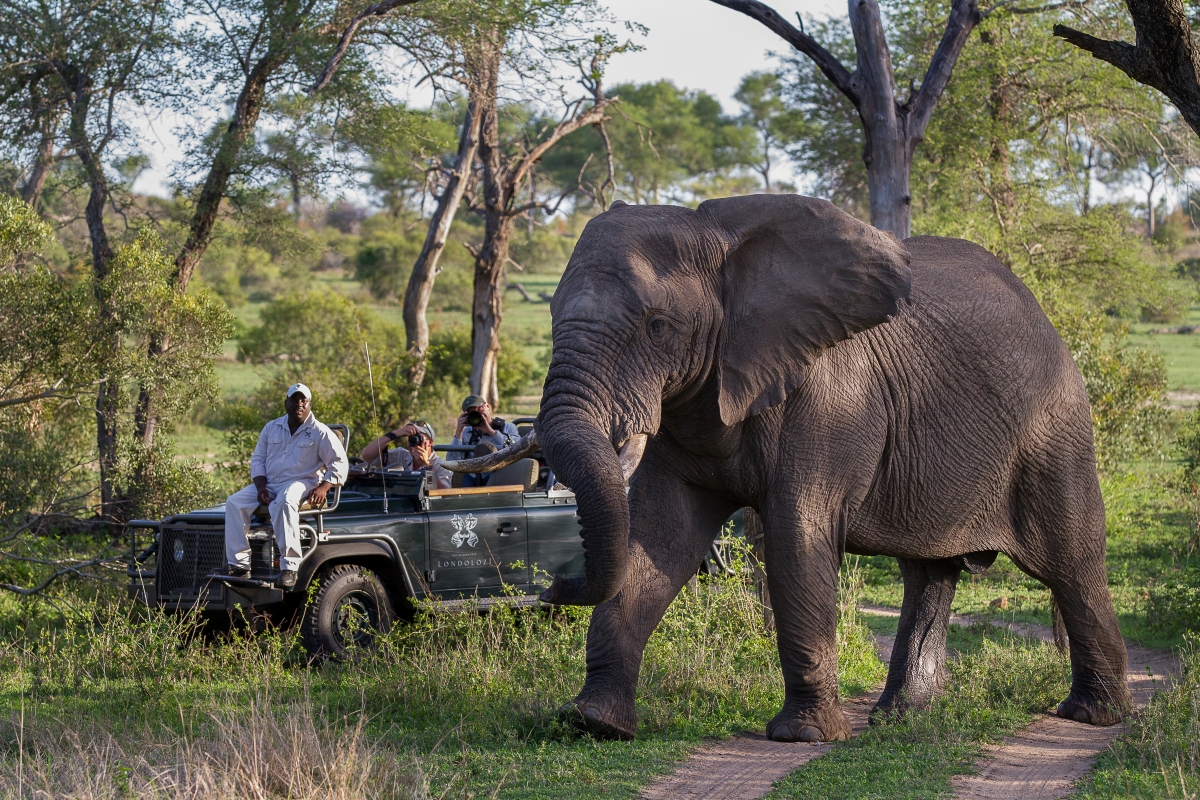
[{"x1": 456, "y1": 194, "x2": 911, "y2": 606}]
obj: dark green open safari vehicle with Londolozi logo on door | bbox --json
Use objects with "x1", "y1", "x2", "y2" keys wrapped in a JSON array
[{"x1": 128, "y1": 419, "x2": 584, "y2": 655}]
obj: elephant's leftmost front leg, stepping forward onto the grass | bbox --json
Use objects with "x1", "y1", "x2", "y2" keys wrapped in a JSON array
[{"x1": 560, "y1": 467, "x2": 734, "y2": 739}]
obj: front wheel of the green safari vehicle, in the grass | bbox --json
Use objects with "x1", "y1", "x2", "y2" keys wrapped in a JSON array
[{"x1": 302, "y1": 564, "x2": 396, "y2": 656}]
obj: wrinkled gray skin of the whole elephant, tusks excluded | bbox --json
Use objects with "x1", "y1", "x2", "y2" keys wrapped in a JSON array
[{"x1": 536, "y1": 196, "x2": 1129, "y2": 741}]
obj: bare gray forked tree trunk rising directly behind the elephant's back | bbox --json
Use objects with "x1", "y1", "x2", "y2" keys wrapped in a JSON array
[{"x1": 713, "y1": 0, "x2": 980, "y2": 239}]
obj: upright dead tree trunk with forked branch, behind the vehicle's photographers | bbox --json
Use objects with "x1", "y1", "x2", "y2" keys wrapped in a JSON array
[{"x1": 470, "y1": 82, "x2": 616, "y2": 408}]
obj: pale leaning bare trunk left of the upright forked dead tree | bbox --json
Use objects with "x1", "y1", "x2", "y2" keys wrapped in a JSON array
[{"x1": 404, "y1": 96, "x2": 479, "y2": 369}]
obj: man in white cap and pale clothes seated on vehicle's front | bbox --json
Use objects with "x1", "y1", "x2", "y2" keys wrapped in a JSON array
[{"x1": 223, "y1": 384, "x2": 350, "y2": 587}]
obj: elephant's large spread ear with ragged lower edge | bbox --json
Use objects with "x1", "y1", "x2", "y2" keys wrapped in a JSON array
[{"x1": 698, "y1": 194, "x2": 912, "y2": 425}]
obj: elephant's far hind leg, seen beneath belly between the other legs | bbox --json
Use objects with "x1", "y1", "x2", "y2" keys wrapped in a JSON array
[{"x1": 871, "y1": 559, "x2": 960, "y2": 722}]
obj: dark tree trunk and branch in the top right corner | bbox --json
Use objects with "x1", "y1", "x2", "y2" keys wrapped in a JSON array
[{"x1": 1054, "y1": 0, "x2": 1200, "y2": 136}]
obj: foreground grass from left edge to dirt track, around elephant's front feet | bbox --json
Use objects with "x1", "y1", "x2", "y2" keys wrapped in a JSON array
[{"x1": 0, "y1": 561, "x2": 883, "y2": 798}]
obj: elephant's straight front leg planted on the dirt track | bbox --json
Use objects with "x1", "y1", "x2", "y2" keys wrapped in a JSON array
[{"x1": 763, "y1": 510, "x2": 851, "y2": 741}]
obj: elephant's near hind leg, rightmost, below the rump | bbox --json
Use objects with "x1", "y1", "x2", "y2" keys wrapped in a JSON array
[{"x1": 1009, "y1": 438, "x2": 1130, "y2": 726}]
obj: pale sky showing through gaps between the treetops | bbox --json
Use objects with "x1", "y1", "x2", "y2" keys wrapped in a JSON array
[{"x1": 134, "y1": 0, "x2": 846, "y2": 199}]
